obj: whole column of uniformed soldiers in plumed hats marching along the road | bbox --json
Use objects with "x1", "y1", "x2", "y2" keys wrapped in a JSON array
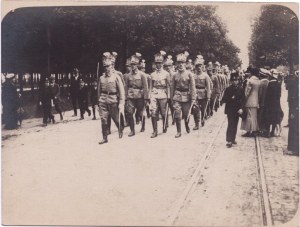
[{"x1": 97, "y1": 51, "x2": 229, "y2": 144}]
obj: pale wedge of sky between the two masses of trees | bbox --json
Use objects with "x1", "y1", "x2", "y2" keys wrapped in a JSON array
[{"x1": 217, "y1": 3, "x2": 261, "y2": 69}]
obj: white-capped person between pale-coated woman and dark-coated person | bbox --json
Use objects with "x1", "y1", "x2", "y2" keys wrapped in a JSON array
[{"x1": 257, "y1": 68, "x2": 271, "y2": 136}]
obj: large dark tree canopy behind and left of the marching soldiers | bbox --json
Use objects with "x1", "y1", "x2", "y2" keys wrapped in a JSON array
[{"x1": 2, "y1": 5, "x2": 241, "y2": 75}]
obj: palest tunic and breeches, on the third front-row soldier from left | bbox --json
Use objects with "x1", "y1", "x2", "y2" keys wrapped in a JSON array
[{"x1": 149, "y1": 69, "x2": 170, "y2": 119}]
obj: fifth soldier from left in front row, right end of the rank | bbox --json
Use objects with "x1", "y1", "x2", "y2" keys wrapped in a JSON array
[{"x1": 193, "y1": 55, "x2": 211, "y2": 130}]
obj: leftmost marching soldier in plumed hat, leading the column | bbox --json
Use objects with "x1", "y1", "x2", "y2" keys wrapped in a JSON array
[{"x1": 98, "y1": 52, "x2": 125, "y2": 144}]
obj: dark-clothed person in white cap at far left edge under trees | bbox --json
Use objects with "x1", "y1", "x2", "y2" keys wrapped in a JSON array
[{"x1": 2, "y1": 73, "x2": 20, "y2": 130}]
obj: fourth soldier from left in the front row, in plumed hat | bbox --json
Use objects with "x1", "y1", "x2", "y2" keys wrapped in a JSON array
[{"x1": 171, "y1": 52, "x2": 196, "y2": 138}]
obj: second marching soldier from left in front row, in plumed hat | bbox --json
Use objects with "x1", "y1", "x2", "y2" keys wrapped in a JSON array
[{"x1": 125, "y1": 53, "x2": 149, "y2": 137}]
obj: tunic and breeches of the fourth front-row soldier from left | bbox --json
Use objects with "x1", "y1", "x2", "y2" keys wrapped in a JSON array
[{"x1": 171, "y1": 70, "x2": 196, "y2": 120}]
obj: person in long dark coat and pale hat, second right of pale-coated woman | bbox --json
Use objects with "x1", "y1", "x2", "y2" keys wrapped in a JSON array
[{"x1": 265, "y1": 74, "x2": 283, "y2": 137}]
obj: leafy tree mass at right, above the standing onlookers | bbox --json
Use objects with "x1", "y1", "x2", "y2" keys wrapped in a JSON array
[{"x1": 249, "y1": 5, "x2": 299, "y2": 72}]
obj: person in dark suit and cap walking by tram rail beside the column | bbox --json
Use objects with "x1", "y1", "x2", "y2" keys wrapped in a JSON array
[{"x1": 221, "y1": 73, "x2": 245, "y2": 147}]
